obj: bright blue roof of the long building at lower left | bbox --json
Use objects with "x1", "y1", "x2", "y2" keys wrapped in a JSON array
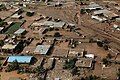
[{"x1": 7, "y1": 56, "x2": 33, "y2": 63}]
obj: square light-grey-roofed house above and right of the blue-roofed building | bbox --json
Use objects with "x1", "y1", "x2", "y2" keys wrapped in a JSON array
[{"x1": 34, "y1": 45, "x2": 51, "y2": 55}]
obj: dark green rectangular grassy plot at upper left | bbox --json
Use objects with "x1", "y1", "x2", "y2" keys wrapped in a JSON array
[{"x1": 5, "y1": 22, "x2": 21, "y2": 34}]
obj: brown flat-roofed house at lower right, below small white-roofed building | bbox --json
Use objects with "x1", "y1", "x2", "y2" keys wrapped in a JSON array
[{"x1": 75, "y1": 58, "x2": 93, "y2": 68}]
